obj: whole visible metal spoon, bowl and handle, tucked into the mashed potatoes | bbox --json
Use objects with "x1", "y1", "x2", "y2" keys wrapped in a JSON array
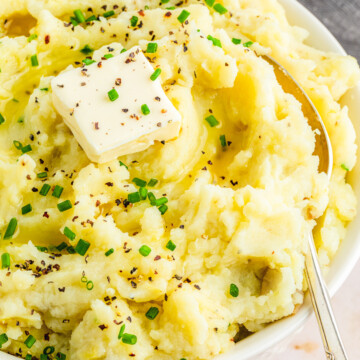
[{"x1": 261, "y1": 55, "x2": 347, "y2": 360}]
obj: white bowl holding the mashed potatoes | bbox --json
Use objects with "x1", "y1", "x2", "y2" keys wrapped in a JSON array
[{"x1": 0, "y1": 0, "x2": 360, "y2": 360}]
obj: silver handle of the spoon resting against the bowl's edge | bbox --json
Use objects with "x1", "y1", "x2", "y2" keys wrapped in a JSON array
[{"x1": 305, "y1": 233, "x2": 347, "y2": 360}]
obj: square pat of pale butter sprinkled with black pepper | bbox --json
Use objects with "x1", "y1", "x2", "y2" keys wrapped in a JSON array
[{"x1": 51, "y1": 46, "x2": 181, "y2": 163}]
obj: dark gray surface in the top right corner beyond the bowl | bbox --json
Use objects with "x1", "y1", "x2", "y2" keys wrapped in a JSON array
[{"x1": 298, "y1": 0, "x2": 360, "y2": 62}]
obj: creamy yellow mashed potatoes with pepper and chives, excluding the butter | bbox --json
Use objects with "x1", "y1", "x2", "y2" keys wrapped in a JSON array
[{"x1": 0, "y1": 0, "x2": 359, "y2": 360}]
